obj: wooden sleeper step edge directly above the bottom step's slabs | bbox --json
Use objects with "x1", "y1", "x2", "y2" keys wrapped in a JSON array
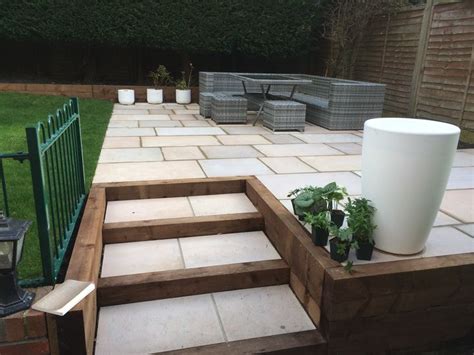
[{"x1": 97, "y1": 259, "x2": 290, "y2": 306}]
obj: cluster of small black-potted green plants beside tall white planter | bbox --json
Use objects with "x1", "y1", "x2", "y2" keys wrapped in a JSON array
[{"x1": 288, "y1": 182, "x2": 375, "y2": 262}]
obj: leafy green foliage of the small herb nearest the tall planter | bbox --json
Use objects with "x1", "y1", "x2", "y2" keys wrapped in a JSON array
[{"x1": 346, "y1": 198, "x2": 376, "y2": 243}]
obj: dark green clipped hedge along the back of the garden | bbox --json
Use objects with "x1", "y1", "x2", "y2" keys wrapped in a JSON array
[{"x1": 0, "y1": 0, "x2": 322, "y2": 56}]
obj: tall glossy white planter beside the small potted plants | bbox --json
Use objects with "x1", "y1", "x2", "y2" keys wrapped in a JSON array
[{"x1": 362, "y1": 118, "x2": 460, "y2": 255}]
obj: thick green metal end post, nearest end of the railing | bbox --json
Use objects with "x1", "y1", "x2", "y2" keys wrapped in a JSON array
[{"x1": 26, "y1": 127, "x2": 55, "y2": 285}]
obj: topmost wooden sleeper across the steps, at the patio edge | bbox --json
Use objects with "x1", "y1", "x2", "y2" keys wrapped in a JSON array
[{"x1": 96, "y1": 177, "x2": 250, "y2": 201}]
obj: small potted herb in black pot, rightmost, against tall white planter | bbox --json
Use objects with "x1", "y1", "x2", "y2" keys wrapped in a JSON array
[{"x1": 346, "y1": 198, "x2": 376, "y2": 260}]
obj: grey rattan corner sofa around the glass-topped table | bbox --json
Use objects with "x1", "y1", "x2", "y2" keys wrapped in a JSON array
[{"x1": 199, "y1": 72, "x2": 385, "y2": 130}]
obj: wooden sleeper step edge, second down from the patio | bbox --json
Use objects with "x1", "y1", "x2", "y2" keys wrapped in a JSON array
[{"x1": 102, "y1": 212, "x2": 264, "y2": 244}]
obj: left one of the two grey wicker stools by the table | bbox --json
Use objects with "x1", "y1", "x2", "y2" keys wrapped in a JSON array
[{"x1": 211, "y1": 93, "x2": 247, "y2": 123}]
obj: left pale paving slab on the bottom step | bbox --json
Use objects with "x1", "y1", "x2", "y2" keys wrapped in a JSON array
[{"x1": 95, "y1": 294, "x2": 225, "y2": 355}]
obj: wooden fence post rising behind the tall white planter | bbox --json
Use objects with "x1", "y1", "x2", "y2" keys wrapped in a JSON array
[{"x1": 408, "y1": 0, "x2": 434, "y2": 117}]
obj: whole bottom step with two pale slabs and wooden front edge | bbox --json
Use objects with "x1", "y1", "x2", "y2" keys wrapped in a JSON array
[{"x1": 96, "y1": 285, "x2": 326, "y2": 355}]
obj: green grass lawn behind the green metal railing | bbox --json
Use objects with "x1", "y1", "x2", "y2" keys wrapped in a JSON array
[{"x1": 0, "y1": 92, "x2": 113, "y2": 279}]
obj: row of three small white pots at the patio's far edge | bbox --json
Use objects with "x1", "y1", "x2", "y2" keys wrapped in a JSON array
[{"x1": 118, "y1": 64, "x2": 194, "y2": 105}]
